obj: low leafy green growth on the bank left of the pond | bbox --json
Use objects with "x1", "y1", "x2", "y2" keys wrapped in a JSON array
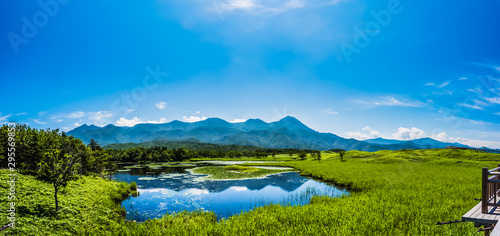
[{"x1": 0, "y1": 170, "x2": 134, "y2": 235}]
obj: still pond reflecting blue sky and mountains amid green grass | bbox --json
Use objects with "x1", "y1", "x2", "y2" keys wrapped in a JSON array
[{"x1": 114, "y1": 162, "x2": 348, "y2": 222}]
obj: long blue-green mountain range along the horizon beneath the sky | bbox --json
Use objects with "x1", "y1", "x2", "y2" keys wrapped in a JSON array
[{"x1": 67, "y1": 116, "x2": 467, "y2": 151}]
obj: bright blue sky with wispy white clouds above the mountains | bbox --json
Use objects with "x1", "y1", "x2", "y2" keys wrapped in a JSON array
[{"x1": 0, "y1": 0, "x2": 500, "y2": 148}]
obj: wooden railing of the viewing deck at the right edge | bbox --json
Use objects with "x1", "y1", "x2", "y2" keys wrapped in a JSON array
[{"x1": 481, "y1": 165, "x2": 500, "y2": 214}]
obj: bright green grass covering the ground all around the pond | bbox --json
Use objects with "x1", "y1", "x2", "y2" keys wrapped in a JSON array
[{"x1": 0, "y1": 150, "x2": 500, "y2": 235}]
